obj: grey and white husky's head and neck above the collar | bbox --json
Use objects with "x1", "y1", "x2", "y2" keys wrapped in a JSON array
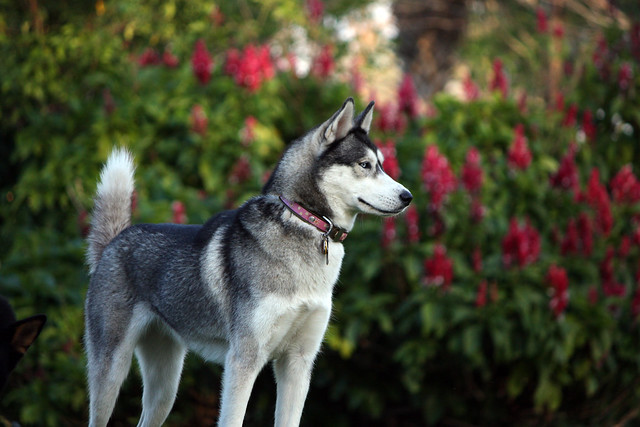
[{"x1": 263, "y1": 98, "x2": 413, "y2": 229}]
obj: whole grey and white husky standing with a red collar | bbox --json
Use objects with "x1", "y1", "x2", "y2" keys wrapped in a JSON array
[{"x1": 85, "y1": 98, "x2": 412, "y2": 427}]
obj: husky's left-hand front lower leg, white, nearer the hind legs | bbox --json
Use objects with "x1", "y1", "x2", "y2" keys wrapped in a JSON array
[{"x1": 218, "y1": 347, "x2": 266, "y2": 427}]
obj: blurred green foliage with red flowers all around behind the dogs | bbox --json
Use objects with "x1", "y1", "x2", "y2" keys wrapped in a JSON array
[{"x1": 0, "y1": 0, "x2": 640, "y2": 426}]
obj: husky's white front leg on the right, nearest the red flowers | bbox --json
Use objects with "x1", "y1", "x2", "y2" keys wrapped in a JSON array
[{"x1": 273, "y1": 309, "x2": 330, "y2": 427}]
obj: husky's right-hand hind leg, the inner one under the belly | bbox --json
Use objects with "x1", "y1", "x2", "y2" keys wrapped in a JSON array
[{"x1": 136, "y1": 324, "x2": 186, "y2": 427}]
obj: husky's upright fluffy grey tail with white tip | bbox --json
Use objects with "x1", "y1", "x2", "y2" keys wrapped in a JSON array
[{"x1": 87, "y1": 148, "x2": 135, "y2": 274}]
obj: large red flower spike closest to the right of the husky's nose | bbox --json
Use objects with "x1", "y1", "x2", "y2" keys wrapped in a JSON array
[{"x1": 422, "y1": 145, "x2": 456, "y2": 211}]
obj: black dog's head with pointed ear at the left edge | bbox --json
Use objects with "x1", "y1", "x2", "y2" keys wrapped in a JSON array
[{"x1": 0, "y1": 297, "x2": 47, "y2": 390}]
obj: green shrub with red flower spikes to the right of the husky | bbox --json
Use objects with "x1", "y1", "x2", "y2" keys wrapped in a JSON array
[{"x1": 330, "y1": 11, "x2": 640, "y2": 424}]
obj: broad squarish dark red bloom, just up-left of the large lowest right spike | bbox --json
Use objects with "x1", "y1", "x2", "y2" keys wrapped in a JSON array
[{"x1": 502, "y1": 218, "x2": 540, "y2": 267}]
